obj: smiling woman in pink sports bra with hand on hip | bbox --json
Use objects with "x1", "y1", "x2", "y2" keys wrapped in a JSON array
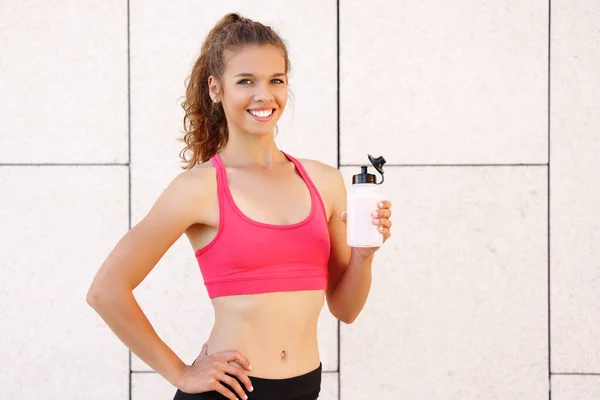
[{"x1": 87, "y1": 14, "x2": 391, "y2": 400}]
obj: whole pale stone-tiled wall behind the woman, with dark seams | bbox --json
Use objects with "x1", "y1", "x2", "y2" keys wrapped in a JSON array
[{"x1": 0, "y1": 0, "x2": 600, "y2": 400}]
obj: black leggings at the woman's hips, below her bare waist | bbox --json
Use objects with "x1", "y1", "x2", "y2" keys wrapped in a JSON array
[{"x1": 173, "y1": 363, "x2": 323, "y2": 400}]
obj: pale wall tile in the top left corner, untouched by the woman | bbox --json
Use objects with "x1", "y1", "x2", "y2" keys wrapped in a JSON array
[{"x1": 0, "y1": 1, "x2": 128, "y2": 163}]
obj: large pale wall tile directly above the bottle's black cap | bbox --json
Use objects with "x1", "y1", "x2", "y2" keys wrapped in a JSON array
[{"x1": 340, "y1": 0, "x2": 548, "y2": 164}]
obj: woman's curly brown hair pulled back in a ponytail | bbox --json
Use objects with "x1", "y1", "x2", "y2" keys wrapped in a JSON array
[{"x1": 179, "y1": 13, "x2": 290, "y2": 170}]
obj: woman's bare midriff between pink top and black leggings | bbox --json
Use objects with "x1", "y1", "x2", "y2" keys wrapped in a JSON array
[{"x1": 207, "y1": 290, "x2": 324, "y2": 379}]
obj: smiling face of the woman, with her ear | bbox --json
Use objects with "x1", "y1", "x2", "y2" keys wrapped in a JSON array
[{"x1": 208, "y1": 45, "x2": 288, "y2": 135}]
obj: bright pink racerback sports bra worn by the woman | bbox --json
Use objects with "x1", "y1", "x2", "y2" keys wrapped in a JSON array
[{"x1": 195, "y1": 152, "x2": 330, "y2": 298}]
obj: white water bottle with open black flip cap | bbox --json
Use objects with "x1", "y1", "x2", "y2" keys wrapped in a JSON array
[{"x1": 346, "y1": 155, "x2": 385, "y2": 247}]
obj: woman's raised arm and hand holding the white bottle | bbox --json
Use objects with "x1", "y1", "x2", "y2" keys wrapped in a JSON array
[{"x1": 326, "y1": 170, "x2": 392, "y2": 324}]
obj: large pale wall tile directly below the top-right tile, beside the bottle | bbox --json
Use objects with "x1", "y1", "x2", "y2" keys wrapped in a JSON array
[{"x1": 340, "y1": 167, "x2": 548, "y2": 400}]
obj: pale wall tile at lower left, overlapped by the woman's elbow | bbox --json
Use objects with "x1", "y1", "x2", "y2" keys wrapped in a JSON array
[{"x1": 0, "y1": 166, "x2": 129, "y2": 400}]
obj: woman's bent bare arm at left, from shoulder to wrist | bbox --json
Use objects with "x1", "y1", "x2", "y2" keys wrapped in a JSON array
[{"x1": 86, "y1": 171, "x2": 207, "y2": 387}]
